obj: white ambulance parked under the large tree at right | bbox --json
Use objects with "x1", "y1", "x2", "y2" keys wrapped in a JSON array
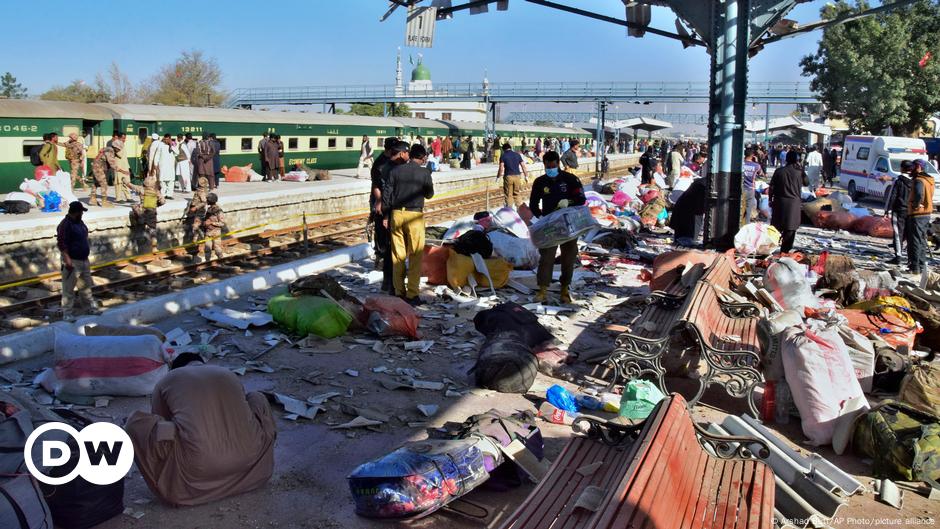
[{"x1": 839, "y1": 136, "x2": 940, "y2": 205}]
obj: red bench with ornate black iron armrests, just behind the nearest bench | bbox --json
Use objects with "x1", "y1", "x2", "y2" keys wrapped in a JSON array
[{"x1": 607, "y1": 280, "x2": 763, "y2": 417}]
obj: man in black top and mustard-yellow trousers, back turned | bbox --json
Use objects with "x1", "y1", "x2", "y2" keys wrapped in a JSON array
[{"x1": 382, "y1": 143, "x2": 434, "y2": 305}]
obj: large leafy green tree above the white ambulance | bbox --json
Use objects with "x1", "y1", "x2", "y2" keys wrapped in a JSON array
[{"x1": 800, "y1": 0, "x2": 940, "y2": 135}]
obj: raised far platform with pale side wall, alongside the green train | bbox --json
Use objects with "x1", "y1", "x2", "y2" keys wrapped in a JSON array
[{"x1": 0, "y1": 154, "x2": 640, "y2": 283}]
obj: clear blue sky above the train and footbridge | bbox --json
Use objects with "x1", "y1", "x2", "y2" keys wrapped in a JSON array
[{"x1": 7, "y1": 0, "x2": 825, "y2": 96}]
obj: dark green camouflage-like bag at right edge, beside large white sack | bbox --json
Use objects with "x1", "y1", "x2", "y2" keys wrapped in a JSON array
[{"x1": 853, "y1": 400, "x2": 940, "y2": 486}]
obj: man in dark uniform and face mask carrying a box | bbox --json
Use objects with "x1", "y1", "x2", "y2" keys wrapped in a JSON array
[{"x1": 529, "y1": 151, "x2": 586, "y2": 303}]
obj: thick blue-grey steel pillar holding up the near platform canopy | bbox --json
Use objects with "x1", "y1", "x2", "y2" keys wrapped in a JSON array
[{"x1": 704, "y1": 0, "x2": 751, "y2": 250}]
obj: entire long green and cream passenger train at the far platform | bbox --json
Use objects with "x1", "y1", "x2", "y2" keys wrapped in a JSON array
[{"x1": 0, "y1": 100, "x2": 591, "y2": 193}]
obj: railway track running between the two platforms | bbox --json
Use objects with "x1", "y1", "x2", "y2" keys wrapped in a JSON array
[{"x1": 0, "y1": 169, "x2": 615, "y2": 335}]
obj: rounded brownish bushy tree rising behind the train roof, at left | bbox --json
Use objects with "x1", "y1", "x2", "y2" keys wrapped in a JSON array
[{"x1": 140, "y1": 50, "x2": 224, "y2": 106}]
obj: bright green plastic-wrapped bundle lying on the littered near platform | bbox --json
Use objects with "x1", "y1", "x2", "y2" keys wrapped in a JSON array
[{"x1": 268, "y1": 294, "x2": 352, "y2": 338}]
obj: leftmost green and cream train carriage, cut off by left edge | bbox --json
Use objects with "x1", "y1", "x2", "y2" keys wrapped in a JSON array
[{"x1": 0, "y1": 99, "x2": 114, "y2": 193}]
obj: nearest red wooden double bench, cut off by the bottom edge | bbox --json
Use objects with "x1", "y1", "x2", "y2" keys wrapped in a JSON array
[{"x1": 499, "y1": 394, "x2": 775, "y2": 529}]
